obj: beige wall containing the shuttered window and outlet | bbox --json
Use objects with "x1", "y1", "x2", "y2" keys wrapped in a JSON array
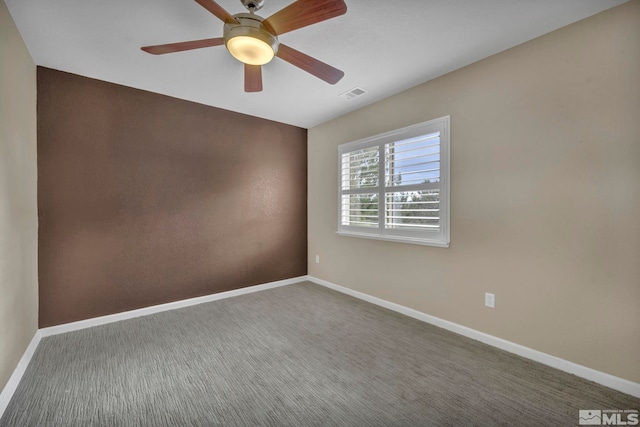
[{"x1": 308, "y1": 0, "x2": 640, "y2": 382}]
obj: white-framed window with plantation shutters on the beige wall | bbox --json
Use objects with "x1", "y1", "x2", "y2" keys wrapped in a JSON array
[{"x1": 338, "y1": 116, "x2": 449, "y2": 247}]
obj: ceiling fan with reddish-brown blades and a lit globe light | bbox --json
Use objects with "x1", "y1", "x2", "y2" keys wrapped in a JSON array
[{"x1": 141, "y1": 0, "x2": 347, "y2": 92}]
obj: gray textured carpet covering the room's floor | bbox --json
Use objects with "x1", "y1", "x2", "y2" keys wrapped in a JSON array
[{"x1": 0, "y1": 283, "x2": 640, "y2": 427}]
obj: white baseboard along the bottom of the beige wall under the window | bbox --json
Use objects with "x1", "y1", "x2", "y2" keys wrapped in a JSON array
[{"x1": 307, "y1": 276, "x2": 640, "y2": 398}]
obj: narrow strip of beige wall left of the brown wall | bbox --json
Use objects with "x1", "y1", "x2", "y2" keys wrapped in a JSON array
[{"x1": 0, "y1": 1, "x2": 38, "y2": 390}]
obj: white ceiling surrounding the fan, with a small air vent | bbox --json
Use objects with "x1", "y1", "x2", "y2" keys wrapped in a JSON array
[{"x1": 5, "y1": 0, "x2": 626, "y2": 128}]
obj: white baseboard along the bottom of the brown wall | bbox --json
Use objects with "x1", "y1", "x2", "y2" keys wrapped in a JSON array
[{"x1": 40, "y1": 276, "x2": 307, "y2": 337}]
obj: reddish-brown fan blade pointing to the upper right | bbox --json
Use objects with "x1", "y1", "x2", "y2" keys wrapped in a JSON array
[{"x1": 262, "y1": 0, "x2": 347, "y2": 35}]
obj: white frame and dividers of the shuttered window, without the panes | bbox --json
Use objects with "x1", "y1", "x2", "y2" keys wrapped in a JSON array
[{"x1": 337, "y1": 116, "x2": 451, "y2": 248}]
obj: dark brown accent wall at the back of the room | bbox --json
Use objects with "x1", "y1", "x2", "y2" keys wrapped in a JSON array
[{"x1": 38, "y1": 67, "x2": 307, "y2": 327}]
